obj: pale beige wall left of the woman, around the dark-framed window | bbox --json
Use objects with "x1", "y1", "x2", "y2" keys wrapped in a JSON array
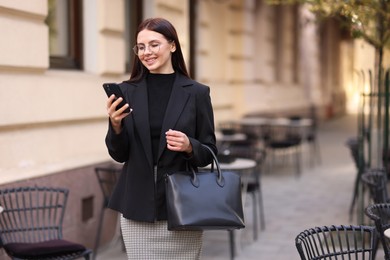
[{"x1": 0, "y1": 0, "x2": 126, "y2": 184}]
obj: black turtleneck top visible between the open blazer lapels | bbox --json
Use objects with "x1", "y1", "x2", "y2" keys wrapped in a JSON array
[{"x1": 146, "y1": 73, "x2": 176, "y2": 164}]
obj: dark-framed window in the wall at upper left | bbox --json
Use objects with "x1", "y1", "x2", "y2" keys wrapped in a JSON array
[{"x1": 46, "y1": 0, "x2": 82, "y2": 69}]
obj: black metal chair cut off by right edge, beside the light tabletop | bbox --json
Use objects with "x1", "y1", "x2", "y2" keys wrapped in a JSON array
[{"x1": 365, "y1": 203, "x2": 390, "y2": 260}]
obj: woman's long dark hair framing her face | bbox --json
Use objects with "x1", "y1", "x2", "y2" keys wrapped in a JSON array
[{"x1": 129, "y1": 18, "x2": 190, "y2": 82}]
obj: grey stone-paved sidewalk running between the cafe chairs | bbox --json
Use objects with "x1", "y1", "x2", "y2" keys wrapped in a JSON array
[{"x1": 97, "y1": 115, "x2": 383, "y2": 260}]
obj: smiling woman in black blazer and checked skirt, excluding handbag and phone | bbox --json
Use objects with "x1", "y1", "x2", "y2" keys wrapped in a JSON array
[{"x1": 106, "y1": 18, "x2": 217, "y2": 260}]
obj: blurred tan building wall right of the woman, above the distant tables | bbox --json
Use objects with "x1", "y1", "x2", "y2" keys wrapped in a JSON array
[{"x1": 197, "y1": 0, "x2": 319, "y2": 123}]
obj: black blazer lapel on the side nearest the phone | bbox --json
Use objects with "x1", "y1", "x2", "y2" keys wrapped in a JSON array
[{"x1": 130, "y1": 80, "x2": 153, "y2": 168}]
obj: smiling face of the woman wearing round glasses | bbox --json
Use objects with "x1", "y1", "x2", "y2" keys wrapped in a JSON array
[{"x1": 137, "y1": 29, "x2": 176, "y2": 74}]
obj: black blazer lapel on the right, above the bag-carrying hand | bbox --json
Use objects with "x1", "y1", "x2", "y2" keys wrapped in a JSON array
[{"x1": 158, "y1": 74, "x2": 191, "y2": 158}]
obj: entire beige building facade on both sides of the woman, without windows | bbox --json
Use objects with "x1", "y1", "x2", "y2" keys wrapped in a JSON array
[{"x1": 0, "y1": 0, "x2": 378, "y2": 184}]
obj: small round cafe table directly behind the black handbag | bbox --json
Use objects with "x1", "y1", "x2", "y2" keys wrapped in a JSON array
[{"x1": 201, "y1": 158, "x2": 256, "y2": 259}]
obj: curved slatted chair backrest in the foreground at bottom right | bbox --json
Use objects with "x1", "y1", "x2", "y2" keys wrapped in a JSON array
[{"x1": 295, "y1": 225, "x2": 376, "y2": 260}]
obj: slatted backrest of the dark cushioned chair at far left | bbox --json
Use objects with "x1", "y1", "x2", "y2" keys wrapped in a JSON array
[{"x1": 0, "y1": 186, "x2": 69, "y2": 244}]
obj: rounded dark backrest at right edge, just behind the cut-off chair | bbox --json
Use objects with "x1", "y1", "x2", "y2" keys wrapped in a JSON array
[{"x1": 361, "y1": 168, "x2": 388, "y2": 204}]
